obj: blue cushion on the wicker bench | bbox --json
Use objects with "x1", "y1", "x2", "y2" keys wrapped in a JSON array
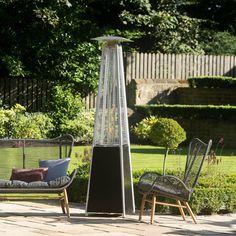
[{"x1": 39, "y1": 158, "x2": 70, "y2": 182}]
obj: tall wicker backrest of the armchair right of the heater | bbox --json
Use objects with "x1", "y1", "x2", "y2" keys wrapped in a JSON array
[{"x1": 183, "y1": 138, "x2": 212, "y2": 189}]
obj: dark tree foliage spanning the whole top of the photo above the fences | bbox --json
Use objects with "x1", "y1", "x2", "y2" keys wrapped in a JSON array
[{"x1": 0, "y1": 0, "x2": 236, "y2": 103}]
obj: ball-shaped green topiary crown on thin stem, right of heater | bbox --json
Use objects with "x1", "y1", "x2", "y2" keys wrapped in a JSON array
[{"x1": 150, "y1": 118, "x2": 186, "y2": 148}]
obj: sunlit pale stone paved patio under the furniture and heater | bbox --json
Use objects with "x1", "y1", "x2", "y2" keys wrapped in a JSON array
[{"x1": 0, "y1": 201, "x2": 236, "y2": 236}]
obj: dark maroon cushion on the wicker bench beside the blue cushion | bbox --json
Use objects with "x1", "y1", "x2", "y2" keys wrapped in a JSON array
[{"x1": 10, "y1": 168, "x2": 48, "y2": 183}]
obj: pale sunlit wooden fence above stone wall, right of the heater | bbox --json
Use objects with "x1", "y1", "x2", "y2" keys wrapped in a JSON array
[{"x1": 125, "y1": 53, "x2": 236, "y2": 83}]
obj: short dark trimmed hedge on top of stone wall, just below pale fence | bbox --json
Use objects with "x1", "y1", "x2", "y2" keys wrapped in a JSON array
[{"x1": 187, "y1": 76, "x2": 236, "y2": 88}]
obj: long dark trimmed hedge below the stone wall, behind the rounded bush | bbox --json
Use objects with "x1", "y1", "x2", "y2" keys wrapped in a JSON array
[{"x1": 136, "y1": 104, "x2": 236, "y2": 120}]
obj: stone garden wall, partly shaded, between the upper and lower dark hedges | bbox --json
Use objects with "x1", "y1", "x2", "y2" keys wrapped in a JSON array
[{"x1": 127, "y1": 79, "x2": 236, "y2": 107}]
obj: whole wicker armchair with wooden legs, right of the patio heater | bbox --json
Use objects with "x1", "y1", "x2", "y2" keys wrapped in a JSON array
[{"x1": 138, "y1": 138, "x2": 212, "y2": 224}]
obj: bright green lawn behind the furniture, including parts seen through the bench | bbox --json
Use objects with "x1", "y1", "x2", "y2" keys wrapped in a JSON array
[{"x1": 0, "y1": 145, "x2": 236, "y2": 179}]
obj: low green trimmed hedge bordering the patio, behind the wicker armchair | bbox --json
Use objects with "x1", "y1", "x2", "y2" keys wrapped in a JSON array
[{"x1": 68, "y1": 170, "x2": 236, "y2": 214}]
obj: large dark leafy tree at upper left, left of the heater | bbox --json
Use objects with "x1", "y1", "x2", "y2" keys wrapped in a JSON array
[{"x1": 0, "y1": 0, "x2": 99, "y2": 96}]
